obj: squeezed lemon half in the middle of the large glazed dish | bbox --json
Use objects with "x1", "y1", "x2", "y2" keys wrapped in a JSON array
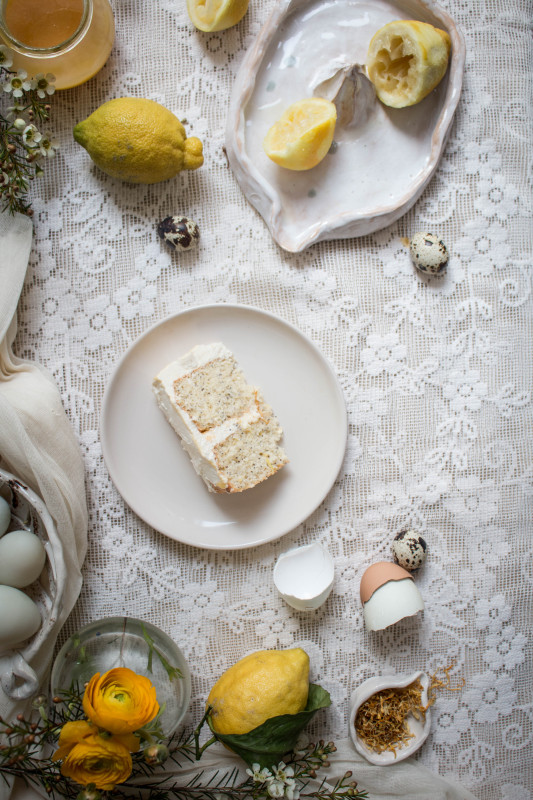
[{"x1": 263, "y1": 97, "x2": 337, "y2": 170}]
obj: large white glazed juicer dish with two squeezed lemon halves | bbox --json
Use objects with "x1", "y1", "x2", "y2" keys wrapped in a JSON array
[{"x1": 226, "y1": 0, "x2": 465, "y2": 252}]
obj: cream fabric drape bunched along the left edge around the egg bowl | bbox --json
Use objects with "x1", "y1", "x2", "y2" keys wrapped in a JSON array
[{"x1": 0, "y1": 213, "x2": 87, "y2": 797}]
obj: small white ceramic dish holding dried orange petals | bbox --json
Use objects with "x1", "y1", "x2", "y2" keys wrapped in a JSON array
[{"x1": 349, "y1": 672, "x2": 431, "y2": 766}]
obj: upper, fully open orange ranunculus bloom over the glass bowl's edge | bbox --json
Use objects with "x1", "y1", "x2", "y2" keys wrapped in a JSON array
[{"x1": 83, "y1": 667, "x2": 159, "y2": 734}]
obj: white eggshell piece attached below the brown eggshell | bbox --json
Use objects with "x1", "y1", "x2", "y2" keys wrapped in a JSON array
[{"x1": 363, "y1": 577, "x2": 424, "y2": 631}]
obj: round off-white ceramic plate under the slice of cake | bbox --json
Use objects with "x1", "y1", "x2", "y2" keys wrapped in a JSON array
[{"x1": 101, "y1": 305, "x2": 347, "y2": 550}]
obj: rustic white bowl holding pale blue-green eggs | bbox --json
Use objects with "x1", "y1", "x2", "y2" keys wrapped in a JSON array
[{"x1": 0, "y1": 469, "x2": 59, "y2": 699}]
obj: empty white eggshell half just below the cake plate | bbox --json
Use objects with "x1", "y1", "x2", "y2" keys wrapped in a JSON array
[{"x1": 273, "y1": 544, "x2": 335, "y2": 611}]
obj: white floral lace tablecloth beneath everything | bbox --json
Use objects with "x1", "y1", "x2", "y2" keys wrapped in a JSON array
[{"x1": 9, "y1": 0, "x2": 533, "y2": 800}]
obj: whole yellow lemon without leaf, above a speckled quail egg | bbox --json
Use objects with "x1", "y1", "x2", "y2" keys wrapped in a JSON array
[{"x1": 74, "y1": 97, "x2": 204, "y2": 183}]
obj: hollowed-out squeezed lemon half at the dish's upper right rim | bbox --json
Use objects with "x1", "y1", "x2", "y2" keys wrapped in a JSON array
[{"x1": 366, "y1": 20, "x2": 450, "y2": 108}]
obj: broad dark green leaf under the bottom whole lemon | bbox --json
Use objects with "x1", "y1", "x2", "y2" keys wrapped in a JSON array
[{"x1": 207, "y1": 683, "x2": 331, "y2": 769}]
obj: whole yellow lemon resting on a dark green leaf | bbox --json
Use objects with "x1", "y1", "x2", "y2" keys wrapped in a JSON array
[{"x1": 207, "y1": 647, "x2": 309, "y2": 734}]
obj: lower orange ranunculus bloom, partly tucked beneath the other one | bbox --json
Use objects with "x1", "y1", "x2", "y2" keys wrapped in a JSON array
[{"x1": 53, "y1": 723, "x2": 132, "y2": 791}]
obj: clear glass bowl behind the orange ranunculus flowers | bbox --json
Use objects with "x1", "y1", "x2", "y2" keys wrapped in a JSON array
[{"x1": 50, "y1": 617, "x2": 191, "y2": 736}]
